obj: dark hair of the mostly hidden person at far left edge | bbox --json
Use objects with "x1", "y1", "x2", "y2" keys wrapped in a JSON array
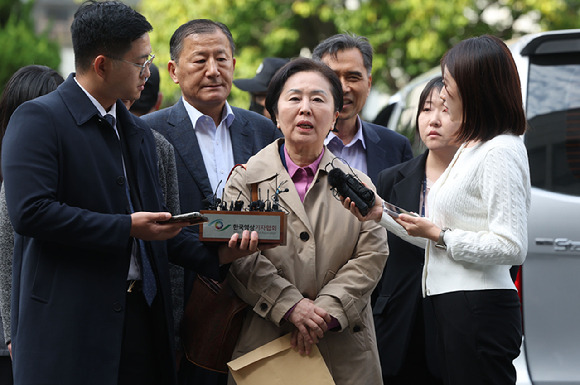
[{"x1": 0, "y1": 65, "x2": 64, "y2": 176}]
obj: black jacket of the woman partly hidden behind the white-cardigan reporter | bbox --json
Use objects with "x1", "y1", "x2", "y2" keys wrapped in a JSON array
[{"x1": 373, "y1": 152, "x2": 438, "y2": 376}]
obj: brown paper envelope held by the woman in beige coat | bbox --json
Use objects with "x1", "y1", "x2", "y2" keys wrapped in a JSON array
[{"x1": 228, "y1": 334, "x2": 335, "y2": 385}]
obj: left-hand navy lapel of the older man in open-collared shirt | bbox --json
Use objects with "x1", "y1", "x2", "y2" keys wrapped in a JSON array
[{"x1": 167, "y1": 99, "x2": 213, "y2": 197}]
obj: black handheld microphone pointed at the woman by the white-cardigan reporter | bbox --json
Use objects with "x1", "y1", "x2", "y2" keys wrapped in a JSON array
[{"x1": 328, "y1": 168, "x2": 375, "y2": 216}]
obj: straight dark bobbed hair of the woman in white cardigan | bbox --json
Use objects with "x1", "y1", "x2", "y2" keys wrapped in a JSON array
[{"x1": 441, "y1": 35, "x2": 526, "y2": 142}]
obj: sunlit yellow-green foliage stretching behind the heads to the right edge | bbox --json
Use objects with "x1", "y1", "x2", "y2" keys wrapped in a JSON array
[{"x1": 141, "y1": 0, "x2": 580, "y2": 108}]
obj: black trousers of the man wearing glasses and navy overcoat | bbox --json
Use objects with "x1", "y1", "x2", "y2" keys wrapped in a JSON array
[{"x1": 118, "y1": 290, "x2": 167, "y2": 385}]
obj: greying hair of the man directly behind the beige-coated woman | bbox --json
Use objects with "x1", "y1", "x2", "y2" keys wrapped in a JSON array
[{"x1": 312, "y1": 33, "x2": 373, "y2": 76}]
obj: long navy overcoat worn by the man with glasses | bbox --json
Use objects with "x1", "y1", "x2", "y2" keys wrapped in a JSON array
[{"x1": 2, "y1": 75, "x2": 219, "y2": 385}]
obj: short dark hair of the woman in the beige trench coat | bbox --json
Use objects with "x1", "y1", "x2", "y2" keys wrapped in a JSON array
[{"x1": 266, "y1": 57, "x2": 342, "y2": 125}]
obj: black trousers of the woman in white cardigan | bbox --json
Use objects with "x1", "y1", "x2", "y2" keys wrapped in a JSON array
[{"x1": 431, "y1": 290, "x2": 522, "y2": 385}]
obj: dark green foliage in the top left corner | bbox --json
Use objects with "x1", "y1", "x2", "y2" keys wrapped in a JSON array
[{"x1": 0, "y1": 0, "x2": 60, "y2": 89}]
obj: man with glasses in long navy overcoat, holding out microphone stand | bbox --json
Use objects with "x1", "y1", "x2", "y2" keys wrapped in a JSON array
[{"x1": 2, "y1": 1, "x2": 257, "y2": 385}]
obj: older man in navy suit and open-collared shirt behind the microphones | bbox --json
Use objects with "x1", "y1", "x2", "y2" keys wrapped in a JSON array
[{"x1": 144, "y1": 19, "x2": 281, "y2": 385}]
